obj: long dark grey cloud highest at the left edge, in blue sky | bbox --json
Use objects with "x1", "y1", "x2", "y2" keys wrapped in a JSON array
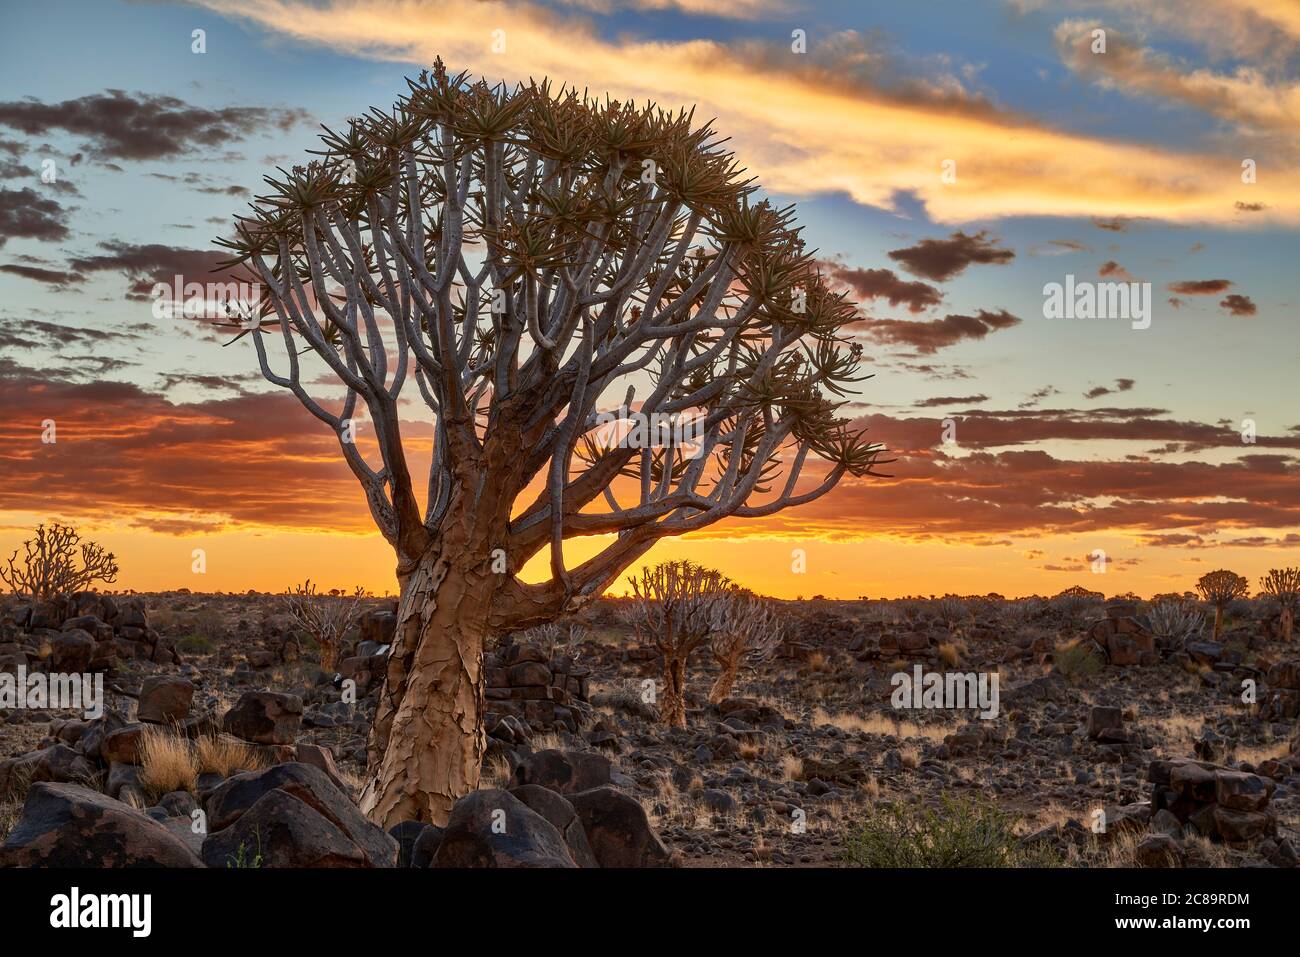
[{"x1": 0, "y1": 90, "x2": 306, "y2": 160}]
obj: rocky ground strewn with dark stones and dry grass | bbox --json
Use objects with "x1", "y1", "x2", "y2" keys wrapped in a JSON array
[{"x1": 0, "y1": 593, "x2": 1300, "y2": 867}]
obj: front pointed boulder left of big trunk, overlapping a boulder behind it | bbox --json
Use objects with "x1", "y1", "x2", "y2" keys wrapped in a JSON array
[{"x1": 203, "y1": 789, "x2": 371, "y2": 867}]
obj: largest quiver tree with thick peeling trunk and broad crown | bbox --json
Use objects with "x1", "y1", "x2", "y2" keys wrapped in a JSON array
[{"x1": 222, "y1": 61, "x2": 880, "y2": 826}]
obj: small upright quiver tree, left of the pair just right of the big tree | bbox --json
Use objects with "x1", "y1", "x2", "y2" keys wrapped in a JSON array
[{"x1": 628, "y1": 562, "x2": 736, "y2": 728}]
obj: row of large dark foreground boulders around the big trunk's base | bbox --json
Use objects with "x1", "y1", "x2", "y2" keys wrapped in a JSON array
[{"x1": 0, "y1": 752, "x2": 672, "y2": 869}]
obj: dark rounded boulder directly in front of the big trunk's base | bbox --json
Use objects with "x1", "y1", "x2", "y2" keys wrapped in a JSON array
[{"x1": 430, "y1": 788, "x2": 577, "y2": 867}]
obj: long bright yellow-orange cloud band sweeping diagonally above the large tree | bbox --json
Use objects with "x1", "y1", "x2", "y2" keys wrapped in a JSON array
[{"x1": 197, "y1": 0, "x2": 1300, "y2": 225}]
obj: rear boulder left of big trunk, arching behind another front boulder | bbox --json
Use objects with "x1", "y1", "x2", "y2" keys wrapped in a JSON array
[{"x1": 204, "y1": 762, "x2": 398, "y2": 867}]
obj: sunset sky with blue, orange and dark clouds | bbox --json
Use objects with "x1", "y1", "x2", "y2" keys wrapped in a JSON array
[{"x1": 0, "y1": 0, "x2": 1300, "y2": 598}]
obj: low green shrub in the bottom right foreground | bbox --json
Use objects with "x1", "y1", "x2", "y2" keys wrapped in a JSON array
[{"x1": 844, "y1": 794, "x2": 1060, "y2": 867}]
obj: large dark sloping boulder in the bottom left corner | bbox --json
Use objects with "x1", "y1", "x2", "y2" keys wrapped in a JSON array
[{"x1": 0, "y1": 783, "x2": 202, "y2": 867}]
